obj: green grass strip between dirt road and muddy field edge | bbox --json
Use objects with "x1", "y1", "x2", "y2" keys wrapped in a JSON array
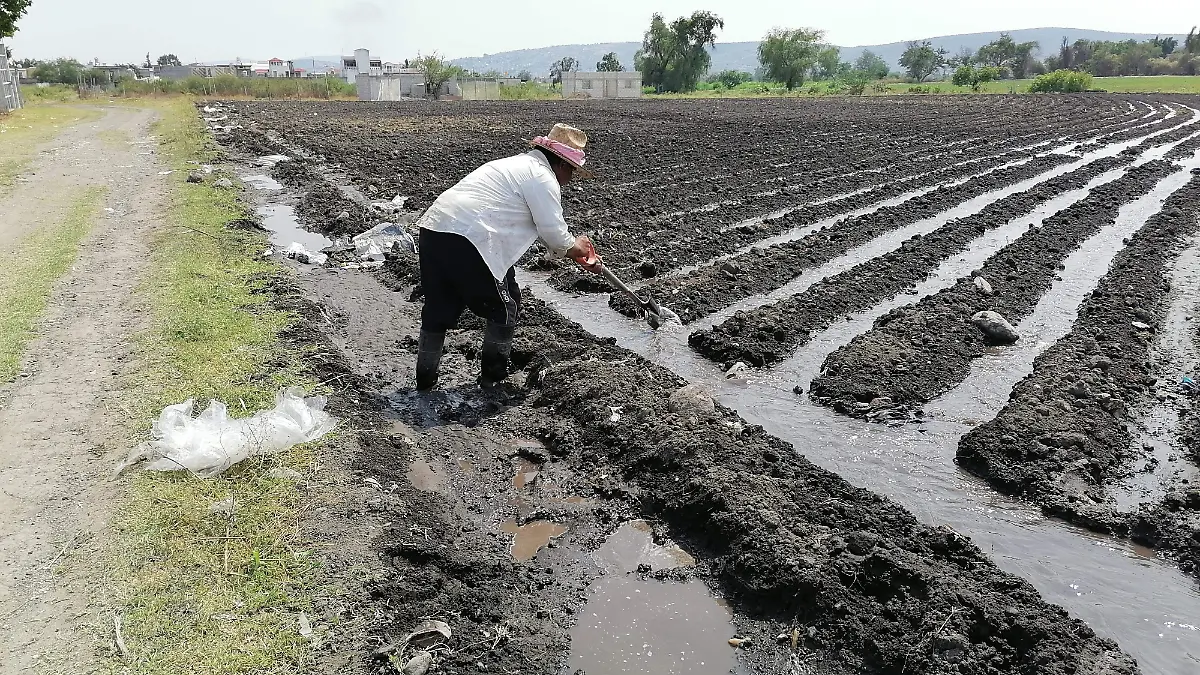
[{"x1": 110, "y1": 98, "x2": 316, "y2": 675}]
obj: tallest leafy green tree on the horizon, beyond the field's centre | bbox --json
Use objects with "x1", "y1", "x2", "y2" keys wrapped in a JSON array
[{"x1": 634, "y1": 12, "x2": 725, "y2": 91}]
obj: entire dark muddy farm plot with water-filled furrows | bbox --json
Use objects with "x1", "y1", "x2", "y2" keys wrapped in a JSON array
[{"x1": 221, "y1": 96, "x2": 1200, "y2": 674}]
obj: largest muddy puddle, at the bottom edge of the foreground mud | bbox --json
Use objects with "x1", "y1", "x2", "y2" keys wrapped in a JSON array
[{"x1": 563, "y1": 520, "x2": 739, "y2": 675}]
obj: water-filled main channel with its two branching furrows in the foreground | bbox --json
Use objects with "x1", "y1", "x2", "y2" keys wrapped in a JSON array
[{"x1": 522, "y1": 144, "x2": 1200, "y2": 675}]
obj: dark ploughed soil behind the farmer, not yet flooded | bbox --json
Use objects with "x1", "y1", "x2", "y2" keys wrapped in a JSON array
[{"x1": 218, "y1": 97, "x2": 1162, "y2": 283}]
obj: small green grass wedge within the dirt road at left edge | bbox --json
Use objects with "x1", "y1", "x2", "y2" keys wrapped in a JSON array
[{"x1": 0, "y1": 187, "x2": 104, "y2": 382}]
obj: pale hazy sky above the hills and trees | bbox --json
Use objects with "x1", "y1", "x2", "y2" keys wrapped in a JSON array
[{"x1": 11, "y1": 0, "x2": 1200, "y2": 62}]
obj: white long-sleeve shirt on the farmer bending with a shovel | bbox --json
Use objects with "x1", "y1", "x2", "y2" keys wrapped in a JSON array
[{"x1": 416, "y1": 150, "x2": 575, "y2": 280}]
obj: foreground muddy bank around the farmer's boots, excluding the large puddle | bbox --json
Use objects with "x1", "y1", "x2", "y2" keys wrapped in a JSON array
[{"x1": 204, "y1": 97, "x2": 1180, "y2": 674}]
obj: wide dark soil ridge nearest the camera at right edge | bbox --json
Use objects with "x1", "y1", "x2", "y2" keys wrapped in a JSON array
[{"x1": 958, "y1": 170, "x2": 1200, "y2": 559}]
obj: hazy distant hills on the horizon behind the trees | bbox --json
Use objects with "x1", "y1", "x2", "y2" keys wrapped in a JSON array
[{"x1": 454, "y1": 28, "x2": 1183, "y2": 76}]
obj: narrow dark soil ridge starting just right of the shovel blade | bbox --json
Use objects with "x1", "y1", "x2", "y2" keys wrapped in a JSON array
[{"x1": 688, "y1": 157, "x2": 1129, "y2": 368}]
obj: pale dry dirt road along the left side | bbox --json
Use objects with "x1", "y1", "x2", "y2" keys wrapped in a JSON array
[{"x1": 0, "y1": 108, "x2": 164, "y2": 675}]
